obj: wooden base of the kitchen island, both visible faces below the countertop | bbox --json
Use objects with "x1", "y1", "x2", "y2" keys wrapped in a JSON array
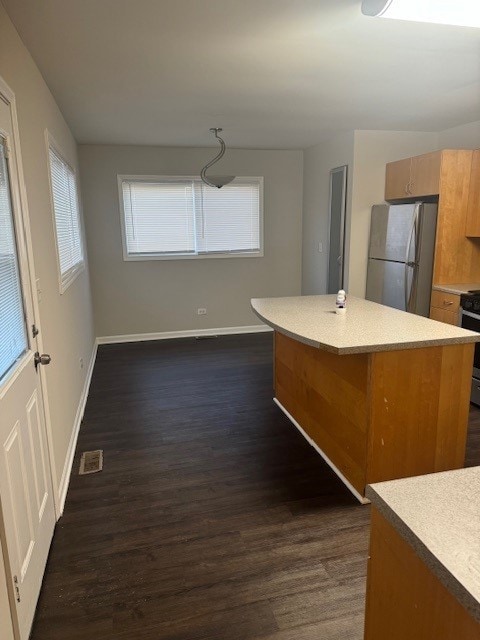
[{"x1": 274, "y1": 331, "x2": 474, "y2": 502}]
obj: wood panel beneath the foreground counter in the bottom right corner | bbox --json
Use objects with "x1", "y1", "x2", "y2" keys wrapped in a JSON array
[{"x1": 365, "y1": 507, "x2": 480, "y2": 640}]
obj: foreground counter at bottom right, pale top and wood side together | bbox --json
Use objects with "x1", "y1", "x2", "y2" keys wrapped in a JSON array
[{"x1": 365, "y1": 467, "x2": 480, "y2": 640}]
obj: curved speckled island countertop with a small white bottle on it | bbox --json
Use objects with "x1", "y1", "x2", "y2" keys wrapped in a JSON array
[{"x1": 251, "y1": 295, "x2": 480, "y2": 355}]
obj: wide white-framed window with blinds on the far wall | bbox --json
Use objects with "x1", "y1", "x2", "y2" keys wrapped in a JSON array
[{"x1": 119, "y1": 176, "x2": 263, "y2": 260}]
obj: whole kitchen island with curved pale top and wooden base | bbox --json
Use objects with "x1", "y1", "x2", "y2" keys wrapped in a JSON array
[{"x1": 251, "y1": 295, "x2": 480, "y2": 502}]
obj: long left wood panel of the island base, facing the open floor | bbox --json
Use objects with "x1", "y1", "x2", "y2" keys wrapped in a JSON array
[{"x1": 275, "y1": 332, "x2": 368, "y2": 495}]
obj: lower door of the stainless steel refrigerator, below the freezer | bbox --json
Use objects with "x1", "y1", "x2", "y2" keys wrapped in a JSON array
[{"x1": 366, "y1": 258, "x2": 415, "y2": 311}]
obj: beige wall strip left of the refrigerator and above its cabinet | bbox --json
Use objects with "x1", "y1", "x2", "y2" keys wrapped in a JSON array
[{"x1": 348, "y1": 131, "x2": 438, "y2": 298}]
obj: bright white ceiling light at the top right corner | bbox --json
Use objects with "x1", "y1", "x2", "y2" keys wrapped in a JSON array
[{"x1": 362, "y1": 0, "x2": 480, "y2": 27}]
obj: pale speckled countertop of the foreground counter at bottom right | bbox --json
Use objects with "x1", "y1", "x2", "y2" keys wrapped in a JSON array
[{"x1": 366, "y1": 467, "x2": 480, "y2": 622}]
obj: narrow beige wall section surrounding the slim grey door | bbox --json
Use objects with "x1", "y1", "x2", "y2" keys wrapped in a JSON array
[{"x1": 302, "y1": 131, "x2": 354, "y2": 295}]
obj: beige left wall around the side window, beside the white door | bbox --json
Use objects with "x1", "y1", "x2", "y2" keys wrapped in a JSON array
[{"x1": 0, "y1": 3, "x2": 94, "y2": 500}]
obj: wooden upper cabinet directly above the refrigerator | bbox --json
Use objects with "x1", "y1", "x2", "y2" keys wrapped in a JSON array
[{"x1": 385, "y1": 151, "x2": 442, "y2": 200}]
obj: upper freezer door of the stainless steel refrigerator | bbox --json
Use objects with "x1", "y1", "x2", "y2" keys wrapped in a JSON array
[{"x1": 369, "y1": 204, "x2": 418, "y2": 262}]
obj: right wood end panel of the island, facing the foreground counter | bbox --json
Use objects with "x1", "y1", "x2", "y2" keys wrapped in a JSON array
[{"x1": 367, "y1": 344, "x2": 474, "y2": 484}]
